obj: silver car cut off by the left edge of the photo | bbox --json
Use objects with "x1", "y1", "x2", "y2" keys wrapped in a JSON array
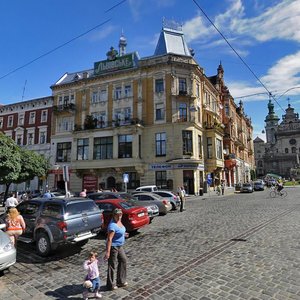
[{"x1": 0, "y1": 224, "x2": 17, "y2": 271}]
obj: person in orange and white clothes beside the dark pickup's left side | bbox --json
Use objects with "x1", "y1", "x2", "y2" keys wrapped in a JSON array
[{"x1": 5, "y1": 207, "x2": 26, "y2": 245}]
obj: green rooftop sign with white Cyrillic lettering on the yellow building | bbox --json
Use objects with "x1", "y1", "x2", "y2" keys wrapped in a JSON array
[{"x1": 94, "y1": 53, "x2": 134, "y2": 75}]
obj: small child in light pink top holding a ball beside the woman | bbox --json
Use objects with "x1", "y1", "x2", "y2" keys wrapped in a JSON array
[{"x1": 82, "y1": 251, "x2": 102, "y2": 300}]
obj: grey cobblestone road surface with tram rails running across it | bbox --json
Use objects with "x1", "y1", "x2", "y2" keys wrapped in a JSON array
[{"x1": 0, "y1": 187, "x2": 300, "y2": 300}]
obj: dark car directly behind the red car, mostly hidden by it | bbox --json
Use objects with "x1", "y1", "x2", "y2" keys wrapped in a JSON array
[{"x1": 88, "y1": 192, "x2": 159, "y2": 223}]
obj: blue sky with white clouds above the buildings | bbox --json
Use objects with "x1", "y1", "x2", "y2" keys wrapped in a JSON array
[{"x1": 0, "y1": 0, "x2": 300, "y2": 137}]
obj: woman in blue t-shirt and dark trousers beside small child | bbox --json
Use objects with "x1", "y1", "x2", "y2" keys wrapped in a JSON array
[{"x1": 104, "y1": 208, "x2": 128, "y2": 290}]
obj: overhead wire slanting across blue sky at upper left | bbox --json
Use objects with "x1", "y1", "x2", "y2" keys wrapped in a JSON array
[{"x1": 0, "y1": 0, "x2": 127, "y2": 80}]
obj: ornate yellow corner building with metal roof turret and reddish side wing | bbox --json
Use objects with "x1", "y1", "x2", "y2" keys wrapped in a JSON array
[{"x1": 0, "y1": 22, "x2": 254, "y2": 194}]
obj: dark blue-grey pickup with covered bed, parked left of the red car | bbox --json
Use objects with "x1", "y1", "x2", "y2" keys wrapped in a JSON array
[{"x1": 0, "y1": 198, "x2": 103, "y2": 256}]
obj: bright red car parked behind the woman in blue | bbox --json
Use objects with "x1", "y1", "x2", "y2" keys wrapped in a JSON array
[{"x1": 94, "y1": 199, "x2": 150, "y2": 232}]
